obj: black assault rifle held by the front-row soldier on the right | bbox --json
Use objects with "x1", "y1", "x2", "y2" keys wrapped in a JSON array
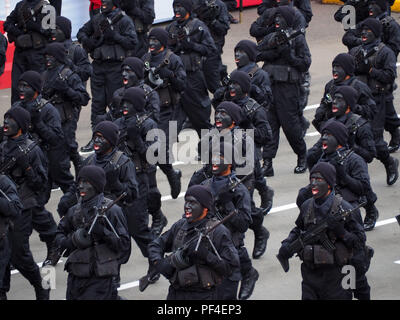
[{"x1": 276, "y1": 202, "x2": 366, "y2": 272}]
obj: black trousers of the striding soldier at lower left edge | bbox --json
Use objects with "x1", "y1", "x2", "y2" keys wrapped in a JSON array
[{"x1": 0, "y1": 209, "x2": 42, "y2": 292}]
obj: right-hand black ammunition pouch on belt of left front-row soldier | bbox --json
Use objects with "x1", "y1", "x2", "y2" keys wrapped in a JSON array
[{"x1": 94, "y1": 243, "x2": 119, "y2": 277}]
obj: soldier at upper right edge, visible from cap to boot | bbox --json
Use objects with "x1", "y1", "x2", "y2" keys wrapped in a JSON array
[{"x1": 349, "y1": 18, "x2": 400, "y2": 185}]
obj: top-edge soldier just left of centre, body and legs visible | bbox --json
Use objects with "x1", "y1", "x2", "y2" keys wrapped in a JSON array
[{"x1": 166, "y1": 0, "x2": 216, "y2": 137}]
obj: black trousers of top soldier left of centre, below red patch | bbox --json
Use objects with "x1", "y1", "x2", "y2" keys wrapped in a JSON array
[{"x1": 90, "y1": 60, "x2": 122, "y2": 129}]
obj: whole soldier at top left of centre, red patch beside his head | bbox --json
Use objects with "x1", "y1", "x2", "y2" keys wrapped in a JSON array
[{"x1": 77, "y1": 0, "x2": 138, "y2": 152}]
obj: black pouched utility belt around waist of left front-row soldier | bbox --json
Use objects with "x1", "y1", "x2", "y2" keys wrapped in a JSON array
[{"x1": 65, "y1": 243, "x2": 119, "y2": 278}]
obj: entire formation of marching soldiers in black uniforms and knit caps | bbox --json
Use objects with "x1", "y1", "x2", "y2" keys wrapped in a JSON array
[{"x1": 0, "y1": 0, "x2": 400, "y2": 300}]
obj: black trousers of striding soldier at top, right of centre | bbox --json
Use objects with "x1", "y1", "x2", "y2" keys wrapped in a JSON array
[{"x1": 263, "y1": 82, "x2": 307, "y2": 159}]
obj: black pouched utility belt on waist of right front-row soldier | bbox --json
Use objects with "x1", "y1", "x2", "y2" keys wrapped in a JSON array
[{"x1": 299, "y1": 241, "x2": 353, "y2": 269}]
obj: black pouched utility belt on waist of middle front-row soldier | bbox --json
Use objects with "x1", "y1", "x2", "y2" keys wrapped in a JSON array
[{"x1": 170, "y1": 264, "x2": 222, "y2": 290}]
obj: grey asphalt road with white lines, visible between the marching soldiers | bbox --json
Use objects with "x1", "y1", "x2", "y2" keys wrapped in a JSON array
[{"x1": 0, "y1": 1, "x2": 400, "y2": 300}]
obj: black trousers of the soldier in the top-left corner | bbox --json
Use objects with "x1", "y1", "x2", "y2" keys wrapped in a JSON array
[{"x1": 11, "y1": 48, "x2": 46, "y2": 104}]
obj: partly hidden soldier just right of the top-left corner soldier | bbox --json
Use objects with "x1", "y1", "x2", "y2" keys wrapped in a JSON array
[{"x1": 50, "y1": 16, "x2": 93, "y2": 87}]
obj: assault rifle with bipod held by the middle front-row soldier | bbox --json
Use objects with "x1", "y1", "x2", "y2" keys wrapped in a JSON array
[{"x1": 139, "y1": 211, "x2": 236, "y2": 292}]
